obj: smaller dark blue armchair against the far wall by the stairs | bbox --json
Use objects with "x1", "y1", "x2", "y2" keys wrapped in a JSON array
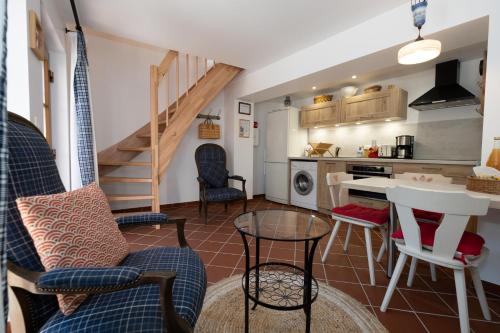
[{"x1": 194, "y1": 143, "x2": 247, "y2": 224}]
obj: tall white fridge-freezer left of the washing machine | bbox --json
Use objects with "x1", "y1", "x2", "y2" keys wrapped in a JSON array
[{"x1": 264, "y1": 107, "x2": 307, "y2": 204}]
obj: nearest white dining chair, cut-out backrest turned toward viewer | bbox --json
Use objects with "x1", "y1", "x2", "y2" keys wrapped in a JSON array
[{"x1": 380, "y1": 186, "x2": 491, "y2": 333}]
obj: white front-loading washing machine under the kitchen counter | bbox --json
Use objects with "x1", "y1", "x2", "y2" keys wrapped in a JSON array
[{"x1": 290, "y1": 161, "x2": 318, "y2": 210}]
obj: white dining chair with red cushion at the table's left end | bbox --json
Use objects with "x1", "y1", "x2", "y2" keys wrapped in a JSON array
[{"x1": 321, "y1": 172, "x2": 389, "y2": 285}]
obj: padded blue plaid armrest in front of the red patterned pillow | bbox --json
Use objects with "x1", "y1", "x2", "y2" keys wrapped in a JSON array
[{"x1": 35, "y1": 266, "x2": 142, "y2": 293}]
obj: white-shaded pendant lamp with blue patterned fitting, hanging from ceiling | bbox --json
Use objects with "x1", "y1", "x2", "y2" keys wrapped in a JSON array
[{"x1": 398, "y1": 0, "x2": 441, "y2": 65}]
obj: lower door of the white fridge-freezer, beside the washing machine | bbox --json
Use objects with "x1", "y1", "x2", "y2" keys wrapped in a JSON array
[{"x1": 266, "y1": 163, "x2": 288, "y2": 204}]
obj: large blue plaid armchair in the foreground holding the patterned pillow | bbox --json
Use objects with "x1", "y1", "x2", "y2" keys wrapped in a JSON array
[{"x1": 7, "y1": 114, "x2": 207, "y2": 333}]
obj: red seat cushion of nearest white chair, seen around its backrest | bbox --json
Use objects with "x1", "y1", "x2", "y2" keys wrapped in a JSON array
[{"x1": 391, "y1": 222, "x2": 484, "y2": 262}]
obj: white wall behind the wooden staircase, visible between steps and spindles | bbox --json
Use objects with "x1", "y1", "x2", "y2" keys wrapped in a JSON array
[{"x1": 86, "y1": 34, "x2": 225, "y2": 209}]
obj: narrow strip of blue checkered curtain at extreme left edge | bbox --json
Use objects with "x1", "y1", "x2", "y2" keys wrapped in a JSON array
[{"x1": 0, "y1": 0, "x2": 9, "y2": 332}]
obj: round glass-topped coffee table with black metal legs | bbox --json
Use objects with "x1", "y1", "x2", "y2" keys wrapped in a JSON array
[{"x1": 234, "y1": 210, "x2": 331, "y2": 332}]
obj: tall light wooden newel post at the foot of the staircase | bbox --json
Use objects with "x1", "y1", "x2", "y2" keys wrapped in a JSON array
[{"x1": 150, "y1": 65, "x2": 160, "y2": 213}]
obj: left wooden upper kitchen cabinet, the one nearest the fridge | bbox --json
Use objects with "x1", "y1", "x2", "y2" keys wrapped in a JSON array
[{"x1": 300, "y1": 101, "x2": 340, "y2": 128}]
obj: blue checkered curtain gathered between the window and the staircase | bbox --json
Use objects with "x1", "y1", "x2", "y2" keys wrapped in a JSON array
[{"x1": 73, "y1": 31, "x2": 96, "y2": 186}]
